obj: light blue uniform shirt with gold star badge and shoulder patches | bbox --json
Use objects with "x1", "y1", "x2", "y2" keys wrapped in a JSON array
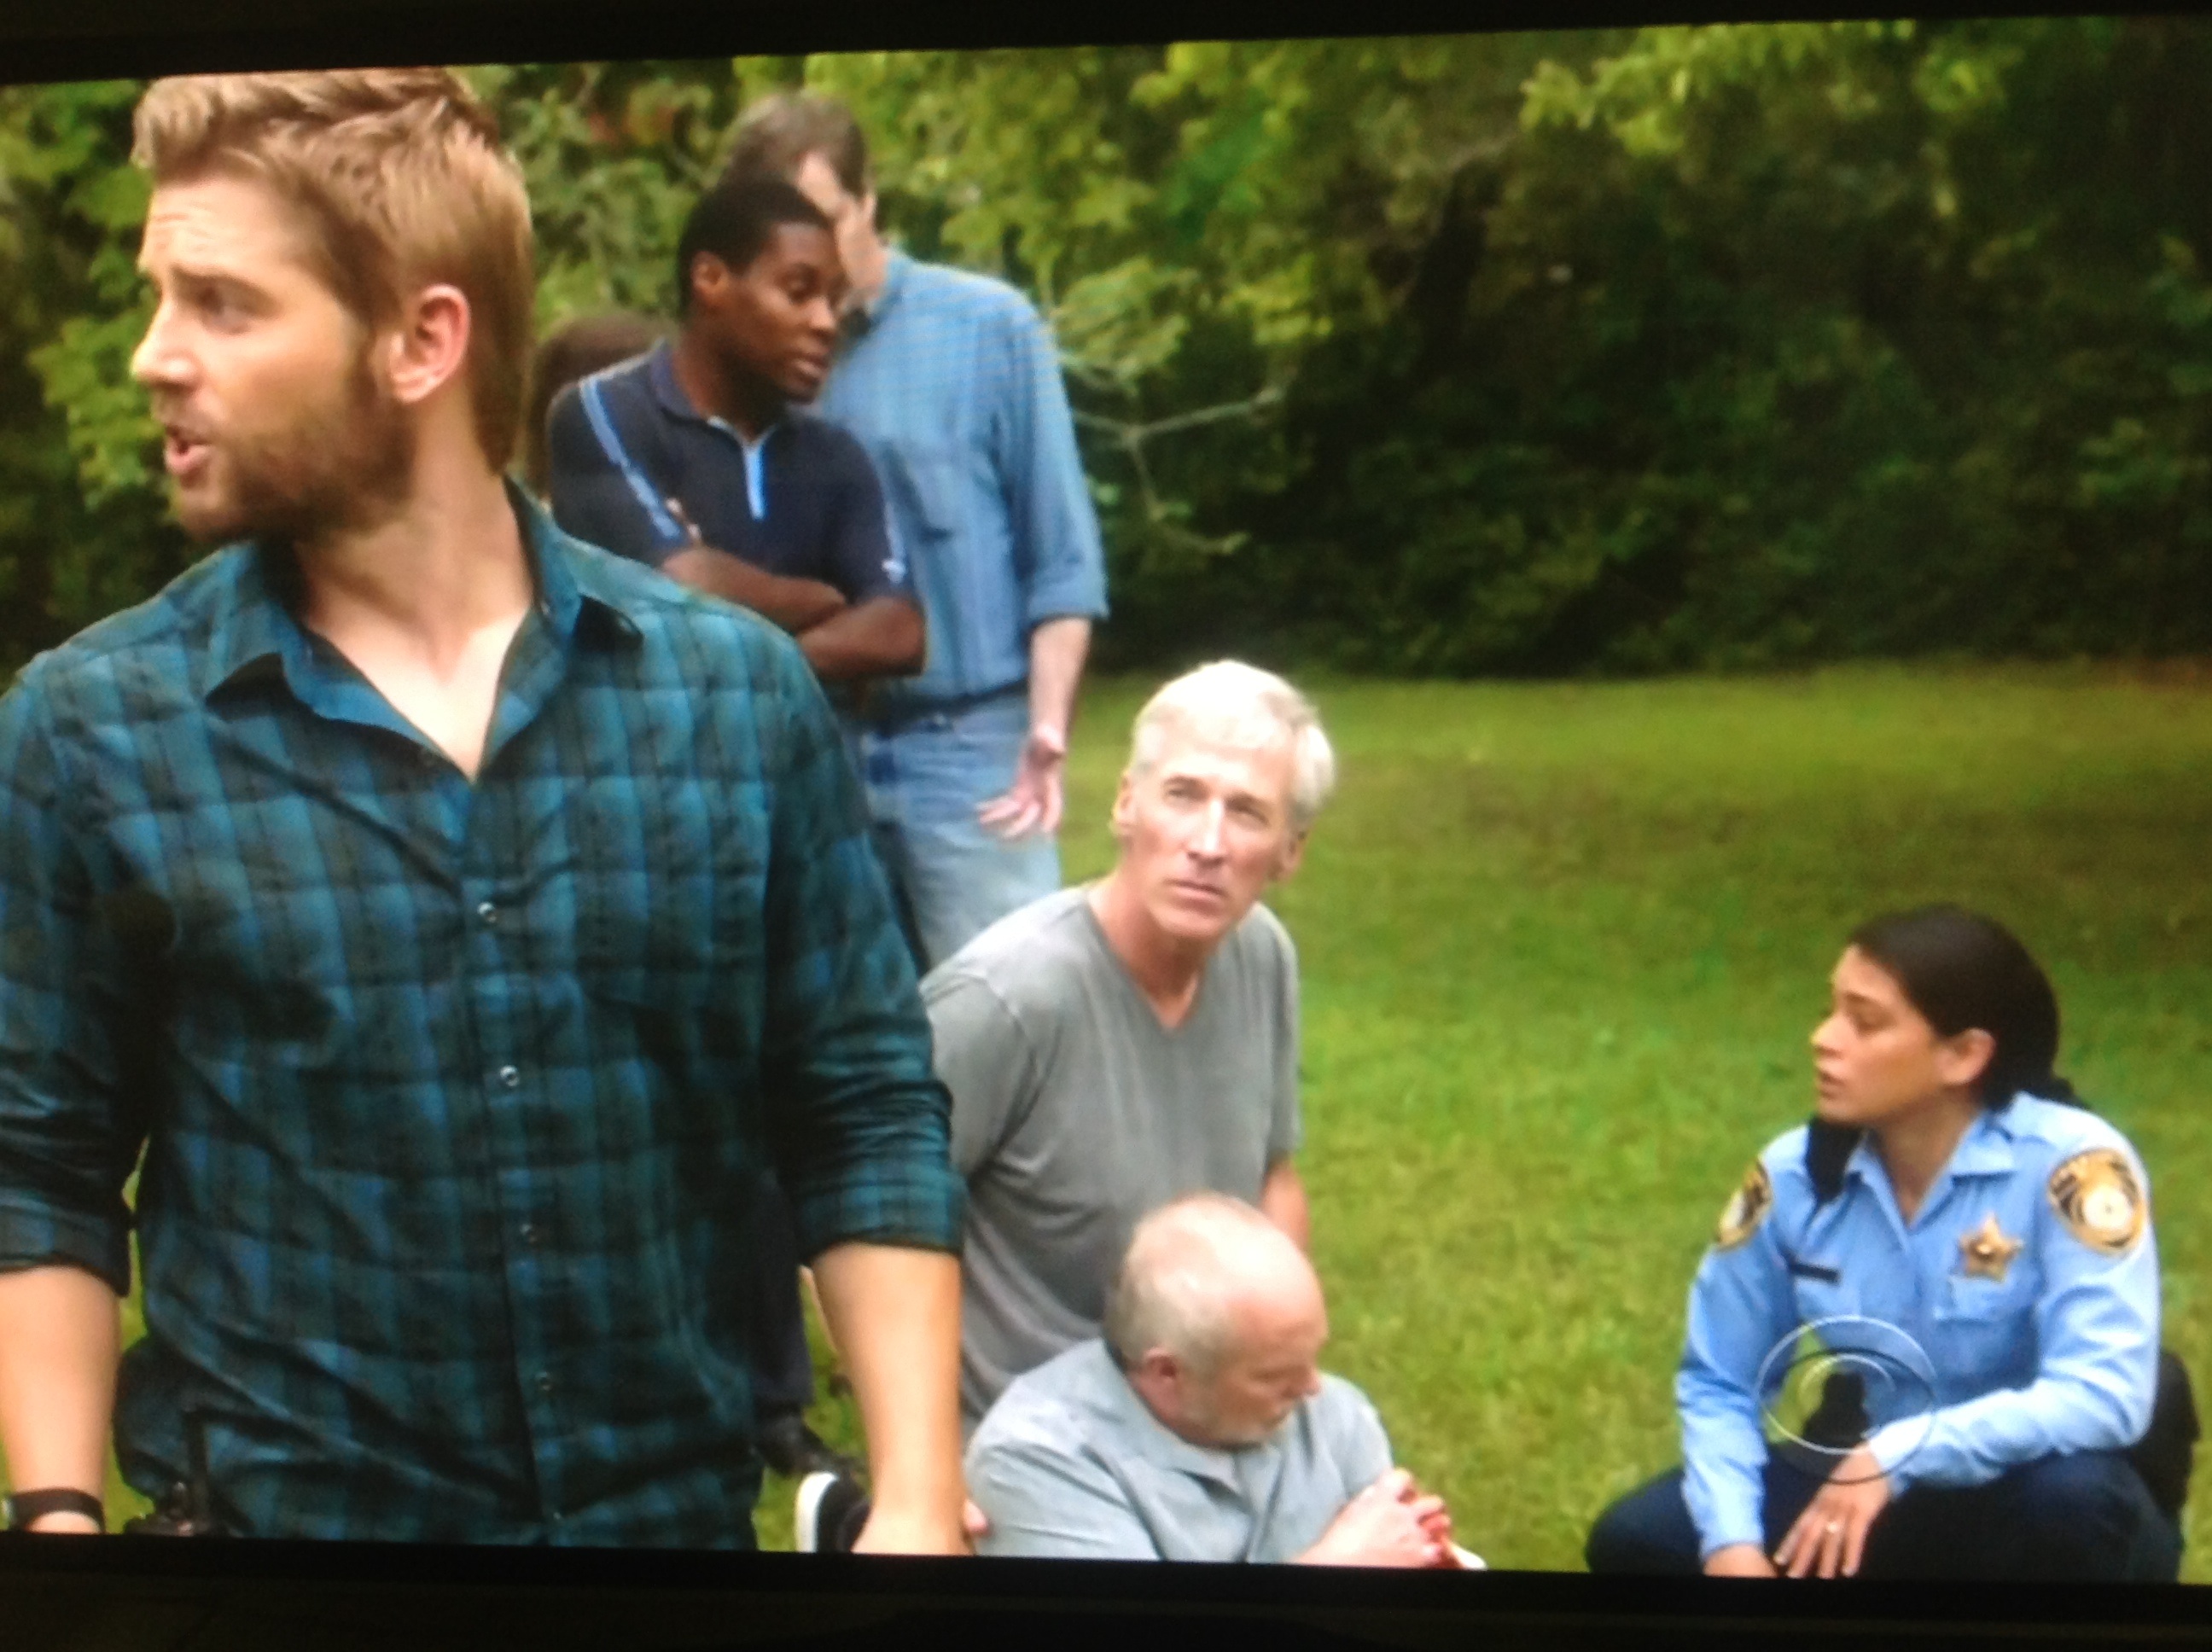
[{"x1": 1674, "y1": 1095, "x2": 2159, "y2": 1555}]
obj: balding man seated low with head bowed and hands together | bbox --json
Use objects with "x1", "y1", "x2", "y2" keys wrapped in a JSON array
[{"x1": 967, "y1": 1195, "x2": 1482, "y2": 1566}]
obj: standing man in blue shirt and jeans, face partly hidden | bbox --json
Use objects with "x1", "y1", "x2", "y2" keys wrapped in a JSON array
[{"x1": 728, "y1": 95, "x2": 1106, "y2": 967}]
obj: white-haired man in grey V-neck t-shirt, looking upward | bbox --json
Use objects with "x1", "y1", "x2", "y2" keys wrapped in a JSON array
[{"x1": 923, "y1": 661, "x2": 1334, "y2": 1428}]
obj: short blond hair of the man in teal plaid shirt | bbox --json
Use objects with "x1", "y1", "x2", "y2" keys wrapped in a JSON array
[{"x1": 131, "y1": 68, "x2": 535, "y2": 468}]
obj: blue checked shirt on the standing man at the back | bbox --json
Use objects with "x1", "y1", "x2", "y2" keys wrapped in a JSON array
[{"x1": 816, "y1": 252, "x2": 1106, "y2": 710}]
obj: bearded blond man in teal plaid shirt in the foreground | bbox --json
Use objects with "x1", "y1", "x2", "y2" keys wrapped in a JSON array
[{"x1": 0, "y1": 68, "x2": 963, "y2": 1552}]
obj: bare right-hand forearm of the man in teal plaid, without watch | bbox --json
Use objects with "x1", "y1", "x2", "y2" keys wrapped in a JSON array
[{"x1": 814, "y1": 1243, "x2": 967, "y2": 1552}]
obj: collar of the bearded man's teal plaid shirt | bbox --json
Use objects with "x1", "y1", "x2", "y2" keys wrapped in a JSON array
[{"x1": 197, "y1": 480, "x2": 639, "y2": 699}]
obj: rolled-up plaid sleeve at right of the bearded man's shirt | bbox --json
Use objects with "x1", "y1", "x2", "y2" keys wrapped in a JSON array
[{"x1": 752, "y1": 635, "x2": 964, "y2": 1256}]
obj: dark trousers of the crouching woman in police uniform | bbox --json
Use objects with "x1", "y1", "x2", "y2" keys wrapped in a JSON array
[{"x1": 1584, "y1": 1451, "x2": 2181, "y2": 1584}]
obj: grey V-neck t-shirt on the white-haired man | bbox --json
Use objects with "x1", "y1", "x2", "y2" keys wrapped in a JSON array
[{"x1": 923, "y1": 889, "x2": 1299, "y2": 1424}]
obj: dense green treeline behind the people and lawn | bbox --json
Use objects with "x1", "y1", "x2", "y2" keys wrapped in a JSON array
[{"x1": 0, "y1": 18, "x2": 2212, "y2": 672}]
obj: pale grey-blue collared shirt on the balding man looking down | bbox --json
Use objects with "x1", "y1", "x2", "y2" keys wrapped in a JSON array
[{"x1": 967, "y1": 1338, "x2": 1391, "y2": 1562}]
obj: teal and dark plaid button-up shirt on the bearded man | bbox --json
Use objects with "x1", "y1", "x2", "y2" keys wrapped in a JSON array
[{"x1": 0, "y1": 502, "x2": 963, "y2": 1546}]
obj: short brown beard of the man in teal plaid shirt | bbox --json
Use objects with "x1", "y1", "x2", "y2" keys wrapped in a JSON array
[{"x1": 172, "y1": 347, "x2": 416, "y2": 546}]
